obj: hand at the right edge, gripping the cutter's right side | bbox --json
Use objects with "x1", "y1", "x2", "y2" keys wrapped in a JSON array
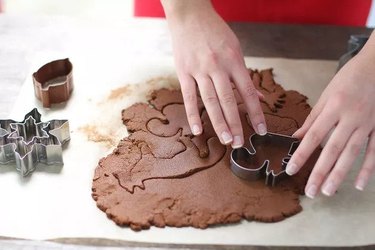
[{"x1": 286, "y1": 38, "x2": 375, "y2": 198}]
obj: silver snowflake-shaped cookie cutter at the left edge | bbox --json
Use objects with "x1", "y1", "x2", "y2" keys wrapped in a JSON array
[{"x1": 0, "y1": 108, "x2": 70, "y2": 177}]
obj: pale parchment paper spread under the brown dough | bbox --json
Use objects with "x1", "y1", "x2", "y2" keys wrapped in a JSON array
[{"x1": 0, "y1": 55, "x2": 375, "y2": 245}]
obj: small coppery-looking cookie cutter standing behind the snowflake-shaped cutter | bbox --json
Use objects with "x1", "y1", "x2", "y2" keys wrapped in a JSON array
[{"x1": 33, "y1": 58, "x2": 73, "y2": 108}]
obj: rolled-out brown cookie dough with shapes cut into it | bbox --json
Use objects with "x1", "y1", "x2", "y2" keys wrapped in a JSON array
[{"x1": 92, "y1": 69, "x2": 319, "y2": 230}]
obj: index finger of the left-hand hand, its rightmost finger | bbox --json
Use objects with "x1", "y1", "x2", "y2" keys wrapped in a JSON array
[{"x1": 232, "y1": 67, "x2": 267, "y2": 135}]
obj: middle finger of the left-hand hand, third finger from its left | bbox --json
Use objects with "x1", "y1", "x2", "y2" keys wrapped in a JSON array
[{"x1": 211, "y1": 73, "x2": 244, "y2": 148}]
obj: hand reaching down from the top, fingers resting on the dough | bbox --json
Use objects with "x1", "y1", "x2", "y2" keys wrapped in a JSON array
[{"x1": 162, "y1": 0, "x2": 267, "y2": 148}]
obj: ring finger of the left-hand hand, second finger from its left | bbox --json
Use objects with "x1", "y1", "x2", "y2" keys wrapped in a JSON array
[{"x1": 195, "y1": 77, "x2": 233, "y2": 144}]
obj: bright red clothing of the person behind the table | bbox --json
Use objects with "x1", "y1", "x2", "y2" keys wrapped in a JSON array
[{"x1": 134, "y1": 0, "x2": 371, "y2": 26}]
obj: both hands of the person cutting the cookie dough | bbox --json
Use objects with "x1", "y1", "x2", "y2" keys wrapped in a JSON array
[{"x1": 162, "y1": 0, "x2": 375, "y2": 198}]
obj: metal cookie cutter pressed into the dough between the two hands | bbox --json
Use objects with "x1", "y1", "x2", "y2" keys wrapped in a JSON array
[{"x1": 230, "y1": 133, "x2": 300, "y2": 186}]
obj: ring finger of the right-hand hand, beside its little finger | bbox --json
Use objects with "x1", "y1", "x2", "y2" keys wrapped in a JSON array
[{"x1": 322, "y1": 129, "x2": 369, "y2": 196}]
